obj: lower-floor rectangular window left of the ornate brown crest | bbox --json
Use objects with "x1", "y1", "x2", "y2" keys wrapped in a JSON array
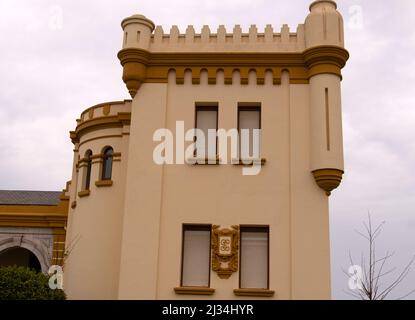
[{"x1": 181, "y1": 225, "x2": 212, "y2": 287}]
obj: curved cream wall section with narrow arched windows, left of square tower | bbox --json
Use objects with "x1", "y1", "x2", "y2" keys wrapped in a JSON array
[{"x1": 65, "y1": 100, "x2": 131, "y2": 299}]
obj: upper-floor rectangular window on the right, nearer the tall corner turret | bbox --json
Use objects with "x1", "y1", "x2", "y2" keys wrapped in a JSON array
[{"x1": 238, "y1": 104, "x2": 261, "y2": 159}]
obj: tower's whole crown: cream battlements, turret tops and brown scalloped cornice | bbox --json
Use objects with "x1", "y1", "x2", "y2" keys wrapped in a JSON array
[{"x1": 118, "y1": 0, "x2": 348, "y2": 97}]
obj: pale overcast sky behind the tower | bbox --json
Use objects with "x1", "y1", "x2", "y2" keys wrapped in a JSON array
[{"x1": 0, "y1": 0, "x2": 415, "y2": 299}]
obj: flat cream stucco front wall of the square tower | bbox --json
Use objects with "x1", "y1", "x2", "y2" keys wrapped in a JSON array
[{"x1": 119, "y1": 69, "x2": 330, "y2": 299}]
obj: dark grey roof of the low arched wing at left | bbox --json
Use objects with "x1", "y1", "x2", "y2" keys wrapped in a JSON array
[{"x1": 0, "y1": 190, "x2": 61, "y2": 206}]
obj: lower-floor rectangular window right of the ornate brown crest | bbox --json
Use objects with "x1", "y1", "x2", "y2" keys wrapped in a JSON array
[{"x1": 239, "y1": 226, "x2": 269, "y2": 289}]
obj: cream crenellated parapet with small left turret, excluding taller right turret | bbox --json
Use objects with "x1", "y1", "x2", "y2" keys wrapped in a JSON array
[{"x1": 122, "y1": 15, "x2": 305, "y2": 53}]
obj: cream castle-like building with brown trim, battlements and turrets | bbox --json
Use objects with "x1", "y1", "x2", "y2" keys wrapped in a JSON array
[{"x1": 0, "y1": 0, "x2": 349, "y2": 299}]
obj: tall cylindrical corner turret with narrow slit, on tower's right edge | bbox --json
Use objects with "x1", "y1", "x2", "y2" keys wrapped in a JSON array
[{"x1": 305, "y1": 0, "x2": 348, "y2": 195}]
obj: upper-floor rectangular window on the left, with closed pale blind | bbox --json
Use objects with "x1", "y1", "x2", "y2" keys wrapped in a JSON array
[{"x1": 196, "y1": 104, "x2": 218, "y2": 159}]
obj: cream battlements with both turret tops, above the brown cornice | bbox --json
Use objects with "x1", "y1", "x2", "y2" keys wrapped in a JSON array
[{"x1": 121, "y1": 0, "x2": 344, "y2": 53}]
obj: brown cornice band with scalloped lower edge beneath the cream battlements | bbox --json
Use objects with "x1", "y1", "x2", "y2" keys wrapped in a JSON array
[{"x1": 118, "y1": 46, "x2": 349, "y2": 97}]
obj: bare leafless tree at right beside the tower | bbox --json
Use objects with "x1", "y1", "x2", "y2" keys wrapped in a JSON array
[{"x1": 344, "y1": 214, "x2": 415, "y2": 300}]
